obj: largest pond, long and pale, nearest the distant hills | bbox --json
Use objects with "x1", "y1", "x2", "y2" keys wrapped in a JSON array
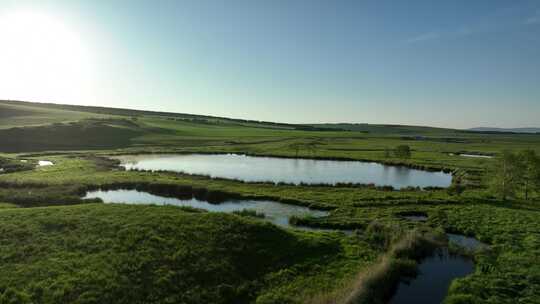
[{"x1": 115, "y1": 154, "x2": 452, "y2": 189}]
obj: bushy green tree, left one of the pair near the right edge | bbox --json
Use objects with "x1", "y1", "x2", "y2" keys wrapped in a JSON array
[{"x1": 491, "y1": 151, "x2": 523, "y2": 200}]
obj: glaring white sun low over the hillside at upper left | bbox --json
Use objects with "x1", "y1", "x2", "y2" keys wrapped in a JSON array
[{"x1": 0, "y1": 12, "x2": 93, "y2": 103}]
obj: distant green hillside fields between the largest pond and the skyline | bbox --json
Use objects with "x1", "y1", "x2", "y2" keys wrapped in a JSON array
[{"x1": 0, "y1": 102, "x2": 540, "y2": 158}]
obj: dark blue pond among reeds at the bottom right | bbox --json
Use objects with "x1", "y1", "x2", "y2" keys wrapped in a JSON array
[{"x1": 390, "y1": 248, "x2": 474, "y2": 304}]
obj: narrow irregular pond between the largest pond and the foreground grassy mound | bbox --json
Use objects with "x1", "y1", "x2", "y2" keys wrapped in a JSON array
[{"x1": 83, "y1": 190, "x2": 328, "y2": 230}]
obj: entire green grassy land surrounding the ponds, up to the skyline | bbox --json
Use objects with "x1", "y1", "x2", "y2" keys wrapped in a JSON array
[{"x1": 0, "y1": 102, "x2": 540, "y2": 303}]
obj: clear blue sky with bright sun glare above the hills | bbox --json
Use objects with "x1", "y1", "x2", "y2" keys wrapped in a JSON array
[{"x1": 0, "y1": 0, "x2": 540, "y2": 128}]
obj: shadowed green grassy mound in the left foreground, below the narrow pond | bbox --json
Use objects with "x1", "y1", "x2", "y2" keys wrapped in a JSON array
[{"x1": 0, "y1": 204, "x2": 369, "y2": 303}]
